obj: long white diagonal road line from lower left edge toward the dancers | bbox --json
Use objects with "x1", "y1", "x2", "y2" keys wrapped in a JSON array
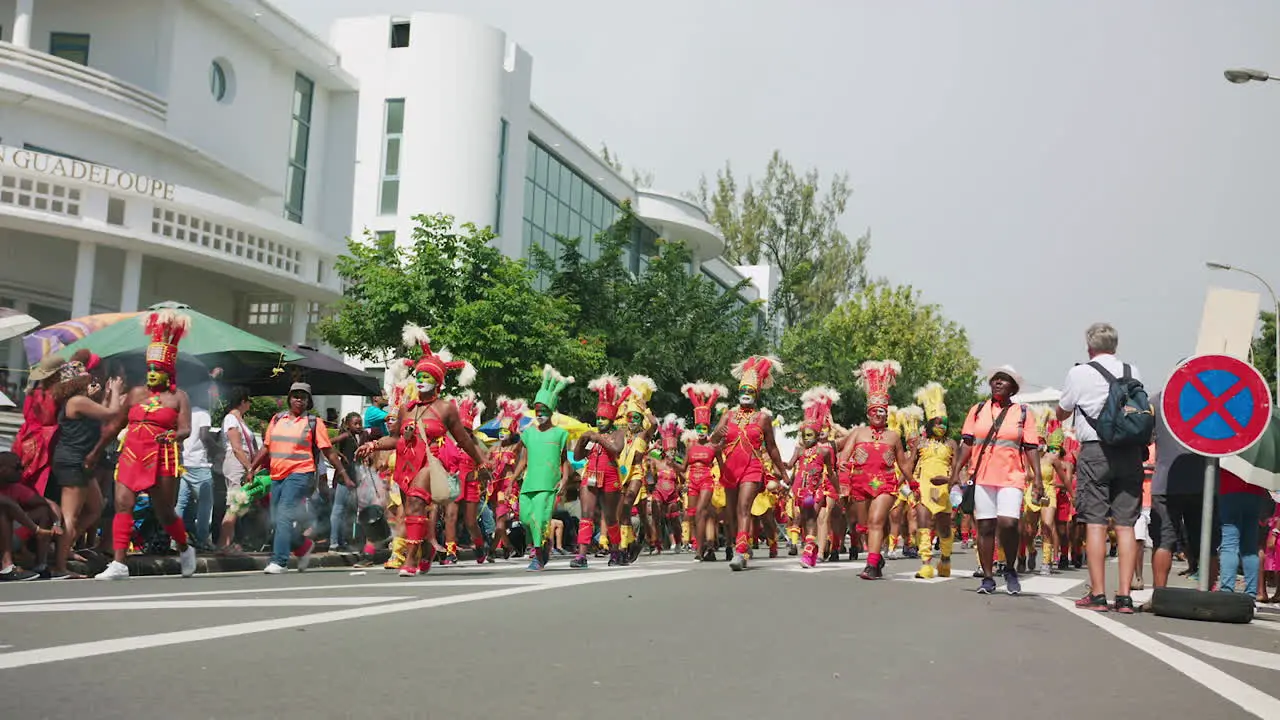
[{"x1": 0, "y1": 570, "x2": 686, "y2": 670}]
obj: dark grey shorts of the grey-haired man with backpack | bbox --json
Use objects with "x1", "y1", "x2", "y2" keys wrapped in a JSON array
[{"x1": 1075, "y1": 442, "x2": 1143, "y2": 528}]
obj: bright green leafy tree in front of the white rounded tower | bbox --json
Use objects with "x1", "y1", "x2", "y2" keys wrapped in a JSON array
[{"x1": 319, "y1": 215, "x2": 603, "y2": 405}]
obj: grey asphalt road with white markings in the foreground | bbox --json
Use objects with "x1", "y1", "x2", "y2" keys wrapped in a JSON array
[{"x1": 0, "y1": 545, "x2": 1280, "y2": 720}]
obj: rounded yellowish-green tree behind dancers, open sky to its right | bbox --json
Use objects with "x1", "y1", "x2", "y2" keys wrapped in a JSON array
[{"x1": 782, "y1": 283, "x2": 979, "y2": 429}]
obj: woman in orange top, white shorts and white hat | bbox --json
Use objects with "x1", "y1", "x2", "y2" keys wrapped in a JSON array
[{"x1": 951, "y1": 365, "x2": 1043, "y2": 594}]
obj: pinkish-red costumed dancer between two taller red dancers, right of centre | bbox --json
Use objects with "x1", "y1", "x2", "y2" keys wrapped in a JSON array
[{"x1": 791, "y1": 387, "x2": 840, "y2": 568}]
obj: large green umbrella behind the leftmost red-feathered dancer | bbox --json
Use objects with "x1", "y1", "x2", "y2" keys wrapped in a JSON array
[{"x1": 59, "y1": 302, "x2": 302, "y2": 384}]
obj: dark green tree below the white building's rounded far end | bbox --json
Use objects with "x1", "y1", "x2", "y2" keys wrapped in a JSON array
[{"x1": 532, "y1": 206, "x2": 764, "y2": 415}]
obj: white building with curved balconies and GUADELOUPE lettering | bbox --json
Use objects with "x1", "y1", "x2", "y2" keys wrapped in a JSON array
[{"x1": 0, "y1": 0, "x2": 358, "y2": 392}]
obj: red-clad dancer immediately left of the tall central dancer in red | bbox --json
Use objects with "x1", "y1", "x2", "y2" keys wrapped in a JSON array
[{"x1": 680, "y1": 380, "x2": 728, "y2": 562}]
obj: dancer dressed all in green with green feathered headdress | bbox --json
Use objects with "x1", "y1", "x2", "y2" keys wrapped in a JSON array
[{"x1": 520, "y1": 365, "x2": 578, "y2": 571}]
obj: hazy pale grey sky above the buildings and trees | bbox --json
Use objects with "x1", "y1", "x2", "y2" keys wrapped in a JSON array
[{"x1": 275, "y1": 0, "x2": 1280, "y2": 389}]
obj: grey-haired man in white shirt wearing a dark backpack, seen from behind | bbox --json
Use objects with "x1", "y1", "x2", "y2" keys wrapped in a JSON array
[{"x1": 1057, "y1": 323, "x2": 1156, "y2": 614}]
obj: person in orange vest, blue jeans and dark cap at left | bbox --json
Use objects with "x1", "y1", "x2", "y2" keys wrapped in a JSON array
[{"x1": 248, "y1": 383, "x2": 356, "y2": 575}]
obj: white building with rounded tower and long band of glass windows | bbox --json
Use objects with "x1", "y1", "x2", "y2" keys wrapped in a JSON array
[{"x1": 330, "y1": 13, "x2": 768, "y2": 319}]
